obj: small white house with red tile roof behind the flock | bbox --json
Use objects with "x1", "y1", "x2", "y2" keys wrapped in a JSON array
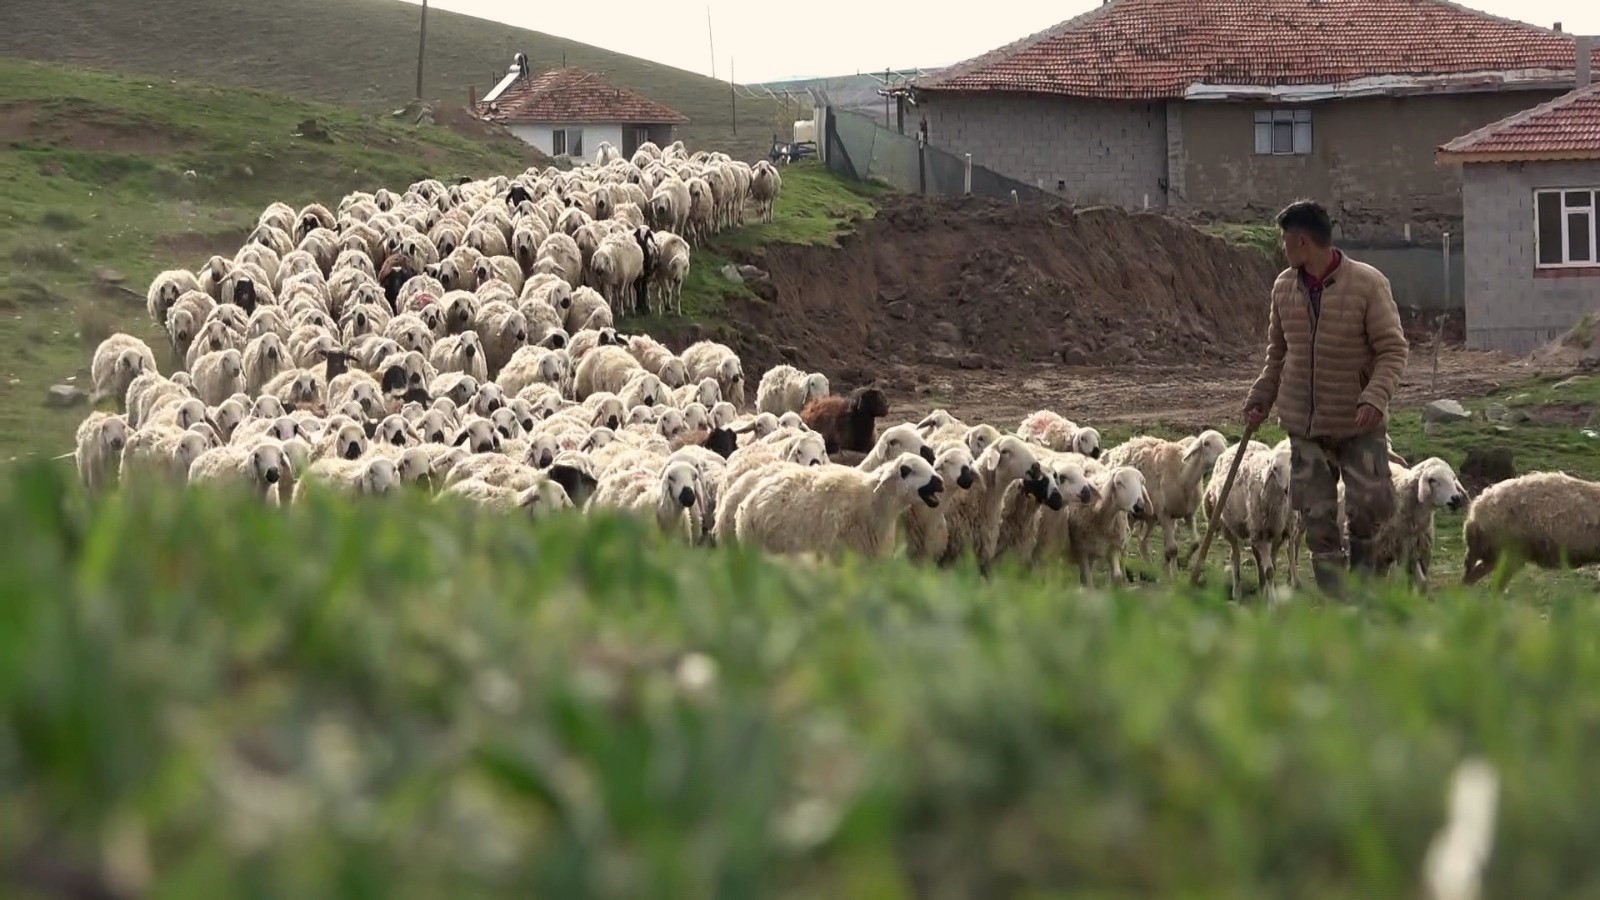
[{"x1": 477, "y1": 64, "x2": 688, "y2": 159}]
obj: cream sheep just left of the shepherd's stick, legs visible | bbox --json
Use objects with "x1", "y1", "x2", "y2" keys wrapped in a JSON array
[{"x1": 1106, "y1": 429, "x2": 1227, "y2": 578}]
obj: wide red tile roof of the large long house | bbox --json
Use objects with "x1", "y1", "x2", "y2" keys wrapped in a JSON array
[{"x1": 912, "y1": 0, "x2": 1600, "y2": 99}]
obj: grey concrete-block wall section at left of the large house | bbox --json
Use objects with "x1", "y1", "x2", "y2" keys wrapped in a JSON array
[{"x1": 907, "y1": 94, "x2": 1168, "y2": 210}]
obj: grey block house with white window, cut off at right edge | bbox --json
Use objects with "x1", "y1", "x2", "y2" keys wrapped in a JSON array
[{"x1": 1437, "y1": 75, "x2": 1600, "y2": 352}]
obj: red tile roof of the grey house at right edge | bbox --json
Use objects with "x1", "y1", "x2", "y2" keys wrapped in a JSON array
[{"x1": 1438, "y1": 83, "x2": 1600, "y2": 162}]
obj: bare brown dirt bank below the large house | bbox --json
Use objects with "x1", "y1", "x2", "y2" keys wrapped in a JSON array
[{"x1": 713, "y1": 190, "x2": 1277, "y2": 384}]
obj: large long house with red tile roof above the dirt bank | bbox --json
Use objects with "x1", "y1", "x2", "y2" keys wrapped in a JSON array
[{"x1": 910, "y1": 0, "x2": 1594, "y2": 245}]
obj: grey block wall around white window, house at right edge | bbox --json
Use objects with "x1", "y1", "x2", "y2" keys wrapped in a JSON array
[{"x1": 1462, "y1": 160, "x2": 1600, "y2": 354}]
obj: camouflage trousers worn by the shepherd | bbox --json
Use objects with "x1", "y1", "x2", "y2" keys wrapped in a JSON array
[{"x1": 1290, "y1": 429, "x2": 1395, "y2": 564}]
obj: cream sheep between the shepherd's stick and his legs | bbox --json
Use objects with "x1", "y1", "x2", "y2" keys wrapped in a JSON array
[{"x1": 1189, "y1": 440, "x2": 1291, "y2": 599}]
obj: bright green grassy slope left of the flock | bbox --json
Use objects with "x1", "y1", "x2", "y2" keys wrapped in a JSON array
[{"x1": 0, "y1": 59, "x2": 526, "y2": 461}]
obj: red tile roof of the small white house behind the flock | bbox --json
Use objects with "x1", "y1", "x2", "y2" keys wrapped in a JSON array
[{"x1": 478, "y1": 67, "x2": 688, "y2": 125}]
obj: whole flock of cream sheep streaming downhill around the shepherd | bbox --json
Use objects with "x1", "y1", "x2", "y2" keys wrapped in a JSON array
[{"x1": 59, "y1": 144, "x2": 1600, "y2": 594}]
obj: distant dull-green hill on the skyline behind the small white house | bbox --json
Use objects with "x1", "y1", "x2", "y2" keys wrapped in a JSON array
[{"x1": 0, "y1": 0, "x2": 794, "y2": 160}]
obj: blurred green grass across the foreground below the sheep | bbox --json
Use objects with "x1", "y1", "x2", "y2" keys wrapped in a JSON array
[{"x1": 0, "y1": 466, "x2": 1600, "y2": 900}]
